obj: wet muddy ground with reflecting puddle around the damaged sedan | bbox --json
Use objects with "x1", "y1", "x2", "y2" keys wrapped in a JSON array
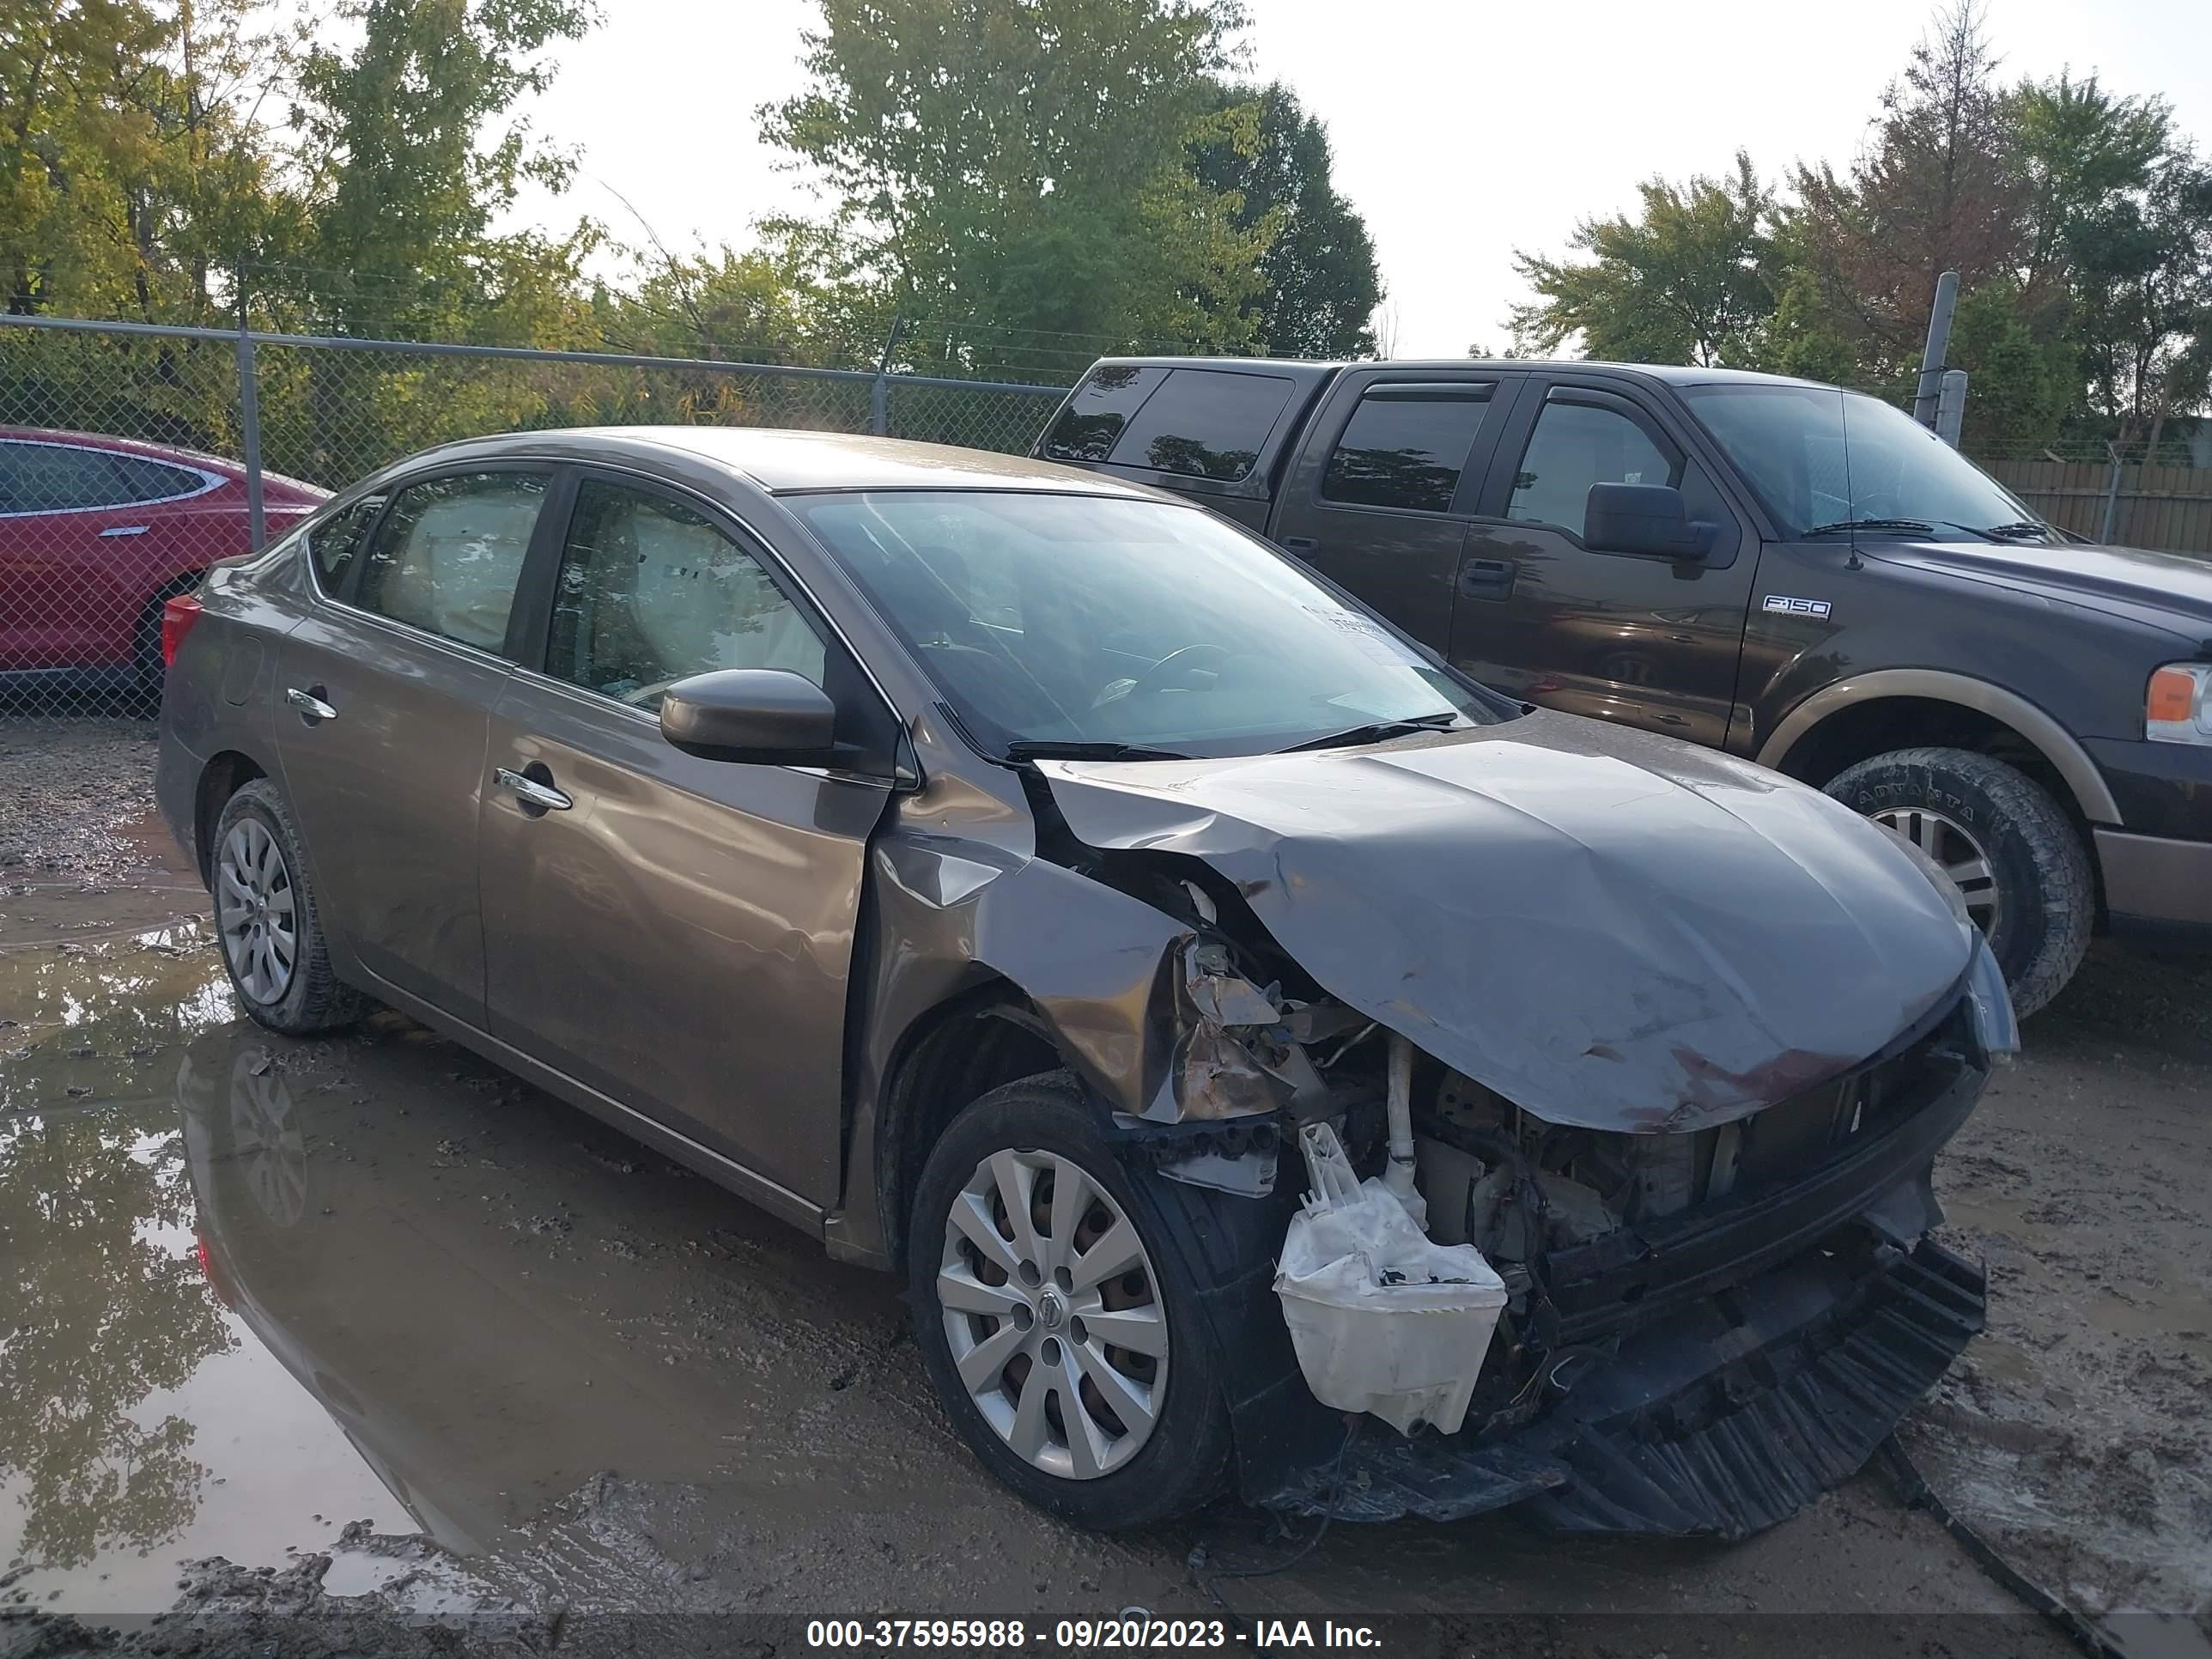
[{"x1": 0, "y1": 721, "x2": 2212, "y2": 1659}]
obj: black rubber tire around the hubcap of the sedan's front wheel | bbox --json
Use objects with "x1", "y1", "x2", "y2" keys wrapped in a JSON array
[{"x1": 907, "y1": 1071, "x2": 1230, "y2": 1533}]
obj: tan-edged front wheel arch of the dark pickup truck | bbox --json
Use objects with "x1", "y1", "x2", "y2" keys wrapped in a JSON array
[{"x1": 1754, "y1": 668, "x2": 2124, "y2": 841}]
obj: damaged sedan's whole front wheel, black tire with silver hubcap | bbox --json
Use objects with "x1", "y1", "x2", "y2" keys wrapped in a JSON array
[{"x1": 907, "y1": 1071, "x2": 1230, "y2": 1531}]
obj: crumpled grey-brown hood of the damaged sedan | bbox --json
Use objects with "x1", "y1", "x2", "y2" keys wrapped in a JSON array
[{"x1": 1040, "y1": 712, "x2": 1973, "y2": 1130}]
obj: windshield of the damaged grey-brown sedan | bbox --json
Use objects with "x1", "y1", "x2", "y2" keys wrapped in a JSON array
[{"x1": 785, "y1": 491, "x2": 1516, "y2": 757}]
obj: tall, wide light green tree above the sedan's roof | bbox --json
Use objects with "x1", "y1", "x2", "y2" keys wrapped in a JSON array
[{"x1": 761, "y1": 0, "x2": 1265, "y2": 354}]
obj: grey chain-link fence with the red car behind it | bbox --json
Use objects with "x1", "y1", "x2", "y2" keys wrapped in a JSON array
[{"x1": 0, "y1": 316, "x2": 1064, "y2": 717}]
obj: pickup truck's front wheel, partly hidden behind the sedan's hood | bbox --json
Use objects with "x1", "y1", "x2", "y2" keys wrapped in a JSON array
[{"x1": 1827, "y1": 748, "x2": 2097, "y2": 1013}]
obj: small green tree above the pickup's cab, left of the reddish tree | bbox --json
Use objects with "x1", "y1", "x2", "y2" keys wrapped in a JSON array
[{"x1": 1510, "y1": 150, "x2": 1774, "y2": 365}]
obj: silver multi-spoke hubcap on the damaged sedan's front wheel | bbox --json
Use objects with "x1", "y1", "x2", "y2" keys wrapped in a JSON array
[{"x1": 938, "y1": 1151, "x2": 1168, "y2": 1480}]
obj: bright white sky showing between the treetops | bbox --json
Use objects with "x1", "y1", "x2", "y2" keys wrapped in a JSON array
[{"x1": 506, "y1": 0, "x2": 2212, "y2": 356}]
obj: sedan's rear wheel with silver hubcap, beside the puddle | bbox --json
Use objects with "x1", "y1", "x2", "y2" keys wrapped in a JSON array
[{"x1": 210, "y1": 779, "x2": 368, "y2": 1036}]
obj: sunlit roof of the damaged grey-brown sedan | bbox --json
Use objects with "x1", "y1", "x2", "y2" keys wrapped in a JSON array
[{"x1": 403, "y1": 424, "x2": 1176, "y2": 500}]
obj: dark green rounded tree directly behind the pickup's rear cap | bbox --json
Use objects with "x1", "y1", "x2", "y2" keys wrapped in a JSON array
[{"x1": 1197, "y1": 82, "x2": 1382, "y2": 356}]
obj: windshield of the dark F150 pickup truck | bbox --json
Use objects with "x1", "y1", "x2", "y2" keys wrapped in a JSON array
[{"x1": 1681, "y1": 385, "x2": 2057, "y2": 542}]
